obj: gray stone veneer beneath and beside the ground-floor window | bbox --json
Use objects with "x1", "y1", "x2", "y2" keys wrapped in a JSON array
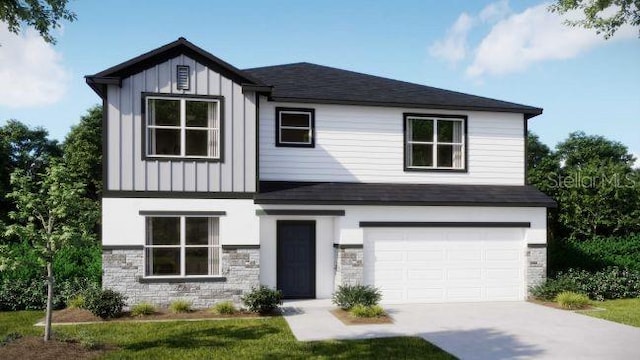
[{"x1": 102, "y1": 247, "x2": 260, "y2": 308}]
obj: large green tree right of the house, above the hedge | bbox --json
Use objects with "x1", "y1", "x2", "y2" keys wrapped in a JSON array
[{"x1": 527, "y1": 132, "x2": 640, "y2": 239}]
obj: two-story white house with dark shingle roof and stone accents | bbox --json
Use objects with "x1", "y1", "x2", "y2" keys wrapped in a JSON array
[{"x1": 86, "y1": 38, "x2": 555, "y2": 307}]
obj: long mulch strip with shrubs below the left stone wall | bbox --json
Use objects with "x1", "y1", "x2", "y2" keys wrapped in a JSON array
[{"x1": 48, "y1": 309, "x2": 259, "y2": 324}]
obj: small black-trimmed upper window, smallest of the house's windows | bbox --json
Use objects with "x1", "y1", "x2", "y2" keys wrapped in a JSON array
[{"x1": 276, "y1": 107, "x2": 315, "y2": 147}]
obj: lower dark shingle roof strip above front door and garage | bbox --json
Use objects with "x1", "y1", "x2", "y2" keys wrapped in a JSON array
[{"x1": 255, "y1": 181, "x2": 556, "y2": 207}]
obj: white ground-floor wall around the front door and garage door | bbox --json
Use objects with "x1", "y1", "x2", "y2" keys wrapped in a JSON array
[{"x1": 259, "y1": 205, "x2": 547, "y2": 298}]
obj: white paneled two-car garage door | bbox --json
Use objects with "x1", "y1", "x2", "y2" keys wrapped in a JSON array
[{"x1": 364, "y1": 228, "x2": 525, "y2": 303}]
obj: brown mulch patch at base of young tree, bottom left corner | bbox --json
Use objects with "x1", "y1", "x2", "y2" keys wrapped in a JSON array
[{"x1": 0, "y1": 336, "x2": 109, "y2": 360}]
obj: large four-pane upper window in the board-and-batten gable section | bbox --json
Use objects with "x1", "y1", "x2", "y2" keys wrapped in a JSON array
[{"x1": 145, "y1": 95, "x2": 222, "y2": 160}]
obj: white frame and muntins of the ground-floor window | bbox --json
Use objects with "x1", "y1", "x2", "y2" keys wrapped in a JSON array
[{"x1": 143, "y1": 214, "x2": 223, "y2": 279}]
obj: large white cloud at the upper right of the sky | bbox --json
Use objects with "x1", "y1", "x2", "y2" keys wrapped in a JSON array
[{"x1": 466, "y1": 3, "x2": 637, "y2": 77}]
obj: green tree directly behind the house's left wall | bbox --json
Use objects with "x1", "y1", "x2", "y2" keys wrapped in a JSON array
[{"x1": 62, "y1": 105, "x2": 102, "y2": 201}]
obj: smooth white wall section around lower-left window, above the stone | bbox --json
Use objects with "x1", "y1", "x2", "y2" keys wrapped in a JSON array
[{"x1": 102, "y1": 198, "x2": 260, "y2": 246}]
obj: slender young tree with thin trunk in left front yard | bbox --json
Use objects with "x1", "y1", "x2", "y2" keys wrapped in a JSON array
[{"x1": 0, "y1": 163, "x2": 97, "y2": 341}]
